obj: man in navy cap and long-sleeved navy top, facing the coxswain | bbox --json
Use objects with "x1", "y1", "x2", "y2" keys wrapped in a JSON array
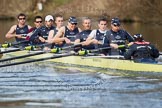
[{"x1": 106, "y1": 17, "x2": 134, "y2": 55}]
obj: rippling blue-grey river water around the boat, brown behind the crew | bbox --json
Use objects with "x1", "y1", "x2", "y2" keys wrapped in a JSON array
[{"x1": 0, "y1": 21, "x2": 162, "y2": 108}]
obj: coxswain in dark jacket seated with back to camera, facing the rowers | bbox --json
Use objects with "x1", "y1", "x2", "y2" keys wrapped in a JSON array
[{"x1": 124, "y1": 34, "x2": 159, "y2": 63}]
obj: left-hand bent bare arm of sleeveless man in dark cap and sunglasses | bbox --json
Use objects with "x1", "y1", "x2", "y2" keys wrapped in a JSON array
[{"x1": 52, "y1": 27, "x2": 65, "y2": 43}]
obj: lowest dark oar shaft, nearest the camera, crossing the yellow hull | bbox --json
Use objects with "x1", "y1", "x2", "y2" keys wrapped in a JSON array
[{"x1": 0, "y1": 52, "x2": 75, "y2": 67}]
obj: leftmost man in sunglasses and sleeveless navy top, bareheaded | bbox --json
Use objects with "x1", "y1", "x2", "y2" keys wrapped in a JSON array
[{"x1": 6, "y1": 13, "x2": 31, "y2": 46}]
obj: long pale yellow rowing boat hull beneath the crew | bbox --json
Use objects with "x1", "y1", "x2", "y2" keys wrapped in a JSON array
[{"x1": 1, "y1": 47, "x2": 162, "y2": 72}]
